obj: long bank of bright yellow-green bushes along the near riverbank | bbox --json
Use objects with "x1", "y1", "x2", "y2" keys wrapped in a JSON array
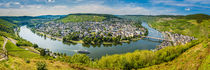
[{"x1": 96, "y1": 41, "x2": 200, "y2": 70}]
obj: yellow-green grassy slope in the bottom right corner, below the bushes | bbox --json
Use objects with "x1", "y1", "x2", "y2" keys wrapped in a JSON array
[{"x1": 140, "y1": 42, "x2": 210, "y2": 70}]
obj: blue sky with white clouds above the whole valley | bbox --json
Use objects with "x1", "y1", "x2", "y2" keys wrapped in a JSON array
[{"x1": 0, "y1": 0, "x2": 210, "y2": 16}]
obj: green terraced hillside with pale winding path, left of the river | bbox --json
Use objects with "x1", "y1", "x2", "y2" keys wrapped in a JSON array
[{"x1": 0, "y1": 19, "x2": 85, "y2": 70}]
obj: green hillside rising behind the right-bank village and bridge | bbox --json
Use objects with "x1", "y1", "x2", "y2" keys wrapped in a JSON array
[{"x1": 150, "y1": 19, "x2": 210, "y2": 38}]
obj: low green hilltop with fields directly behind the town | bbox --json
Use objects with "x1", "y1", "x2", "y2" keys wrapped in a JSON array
[{"x1": 57, "y1": 14, "x2": 118, "y2": 23}]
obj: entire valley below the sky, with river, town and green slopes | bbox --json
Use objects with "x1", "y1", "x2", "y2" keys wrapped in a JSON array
[{"x1": 0, "y1": 15, "x2": 209, "y2": 70}]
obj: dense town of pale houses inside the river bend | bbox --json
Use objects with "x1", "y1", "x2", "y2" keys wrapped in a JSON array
[{"x1": 35, "y1": 18, "x2": 146, "y2": 44}]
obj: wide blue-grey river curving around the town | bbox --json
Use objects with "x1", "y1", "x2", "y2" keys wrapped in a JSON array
[{"x1": 19, "y1": 22, "x2": 162, "y2": 58}]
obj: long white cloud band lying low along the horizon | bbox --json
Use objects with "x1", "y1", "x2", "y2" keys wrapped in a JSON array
[{"x1": 0, "y1": 4, "x2": 178, "y2": 16}]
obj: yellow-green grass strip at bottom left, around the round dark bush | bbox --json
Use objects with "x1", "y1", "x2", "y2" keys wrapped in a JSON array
[{"x1": 0, "y1": 56, "x2": 74, "y2": 70}]
